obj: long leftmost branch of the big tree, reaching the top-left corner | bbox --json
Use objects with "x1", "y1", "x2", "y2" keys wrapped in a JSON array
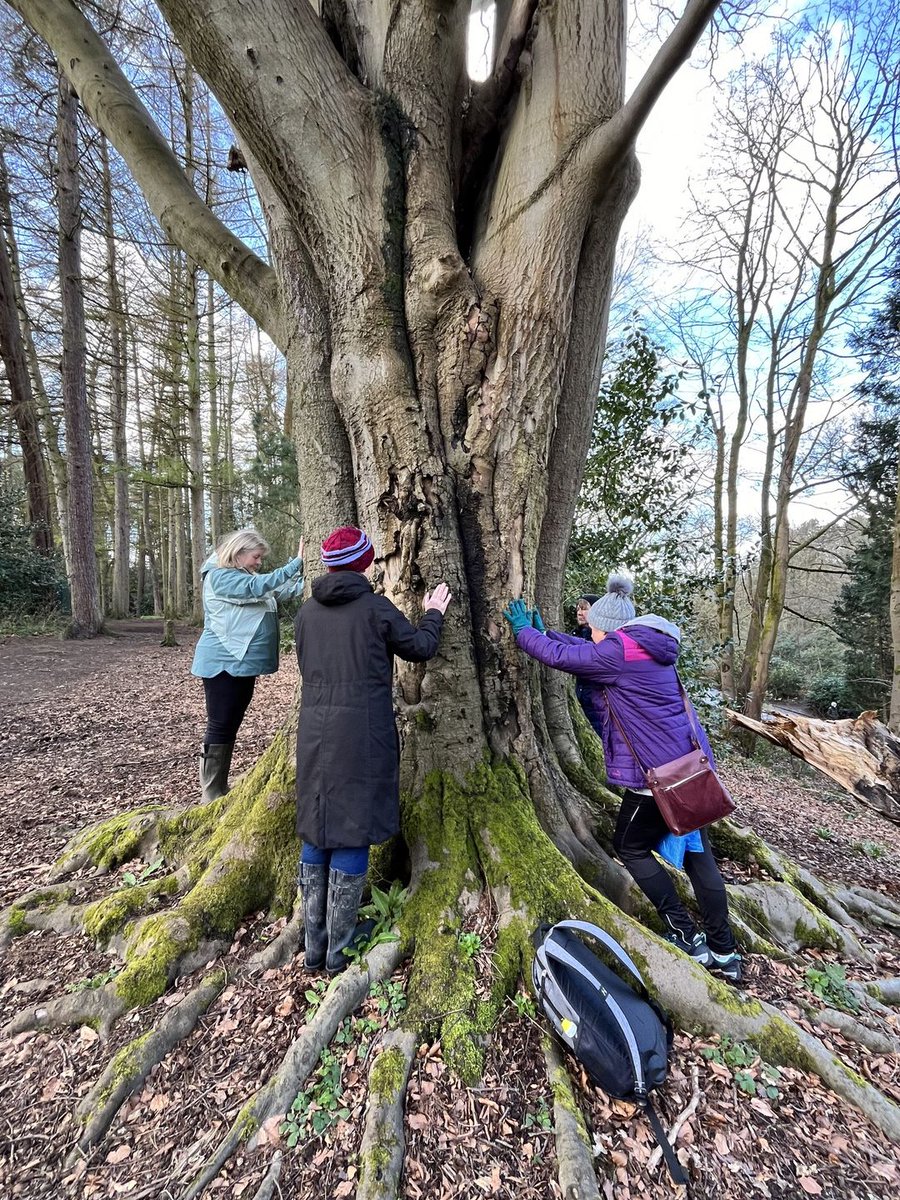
[{"x1": 11, "y1": 0, "x2": 282, "y2": 344}]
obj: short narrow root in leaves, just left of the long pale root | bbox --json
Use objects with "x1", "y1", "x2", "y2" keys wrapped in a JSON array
[{"x1": 66, "y1": 970, "x2": 227, "y2": 1166}]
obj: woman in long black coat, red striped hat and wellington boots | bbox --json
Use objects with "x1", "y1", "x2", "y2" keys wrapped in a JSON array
[{"x1": 295, "y1": 526, "x2": 450, "y2": 973}]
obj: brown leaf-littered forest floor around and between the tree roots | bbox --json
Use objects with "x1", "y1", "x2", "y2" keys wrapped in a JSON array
[{"x1": 0, "y1": 622, "x2": 900, "y2": 1200}]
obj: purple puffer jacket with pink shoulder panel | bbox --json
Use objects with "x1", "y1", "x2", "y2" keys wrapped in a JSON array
[{"x1": 516, "y1": 625, "x2": 713, "y2": 787}]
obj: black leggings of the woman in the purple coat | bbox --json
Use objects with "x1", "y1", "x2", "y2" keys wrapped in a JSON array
[{"x1": 612, "y1": 791, "x2": 734, "y2": 954}]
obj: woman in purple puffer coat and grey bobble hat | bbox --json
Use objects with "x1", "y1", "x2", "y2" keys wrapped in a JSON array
[{"x1": 504, "y1": 575, "x2": 740, "y2": 982}]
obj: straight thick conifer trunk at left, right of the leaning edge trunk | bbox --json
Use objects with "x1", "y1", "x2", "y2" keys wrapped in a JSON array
[{"x1": 56, "y1": 74, "x2": 103, "y2": 637}]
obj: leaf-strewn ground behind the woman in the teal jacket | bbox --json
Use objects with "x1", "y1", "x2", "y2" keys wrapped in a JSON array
[{"x1": 0, "y1": 620, "x2": 296, "y2": 906}]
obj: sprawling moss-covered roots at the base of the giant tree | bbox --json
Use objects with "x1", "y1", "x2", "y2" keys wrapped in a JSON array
[{"x1": 2, "y1": 734, "x2": 900, "y2": 1200}]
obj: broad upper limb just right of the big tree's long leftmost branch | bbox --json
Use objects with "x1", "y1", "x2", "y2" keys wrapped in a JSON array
[{"x1": 160, "y1": 0, "x2": 388, "y2": 298}]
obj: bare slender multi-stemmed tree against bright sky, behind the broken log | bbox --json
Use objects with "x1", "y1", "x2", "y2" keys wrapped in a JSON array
[{"x1": 691, "y1": 5, "x2": 900, "y2": 716}]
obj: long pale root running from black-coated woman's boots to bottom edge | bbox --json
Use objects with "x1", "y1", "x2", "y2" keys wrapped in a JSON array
[{"x1": 184, "y1": 942, "x2": 402, "y2": 1200}]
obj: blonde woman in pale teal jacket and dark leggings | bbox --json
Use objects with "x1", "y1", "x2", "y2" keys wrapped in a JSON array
[{"x1": 191, "y1": 529, "x2": 304, "y2": 800}]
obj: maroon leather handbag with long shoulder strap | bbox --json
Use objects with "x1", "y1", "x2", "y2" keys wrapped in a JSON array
[{"x1": 604, "y1": 672, "x2": 734, "y2": 835}]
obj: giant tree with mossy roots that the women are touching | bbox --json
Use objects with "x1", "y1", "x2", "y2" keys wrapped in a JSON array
[{"x1": 5, "y1": 0, "x2": 900, "y2": 1180}]
